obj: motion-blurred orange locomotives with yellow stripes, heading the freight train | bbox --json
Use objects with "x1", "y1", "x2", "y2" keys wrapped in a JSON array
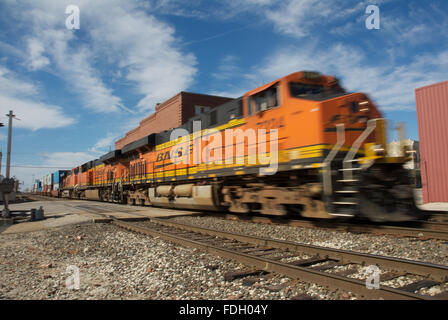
[{"x1": 33, "y1": 71, "x2": 423, "y2": 222}]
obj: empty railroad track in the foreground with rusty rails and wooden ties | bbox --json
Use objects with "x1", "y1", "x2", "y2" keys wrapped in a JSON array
[{"x1": 76, "y1": 209, "x2": 448, "y2": 300}]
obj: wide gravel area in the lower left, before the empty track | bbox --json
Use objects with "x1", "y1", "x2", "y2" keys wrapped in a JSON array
[{"x1": 0, "y1": 224, "x2": 355, "y2": 300}]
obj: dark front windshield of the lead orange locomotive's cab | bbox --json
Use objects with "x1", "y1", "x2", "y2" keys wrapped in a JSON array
[{"x1": 289, "y1": 82, "x2": 346, "y2": 101}]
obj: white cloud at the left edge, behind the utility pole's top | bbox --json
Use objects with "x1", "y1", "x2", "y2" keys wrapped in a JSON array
[{"x1": 0, "y1": 66, "x2": 75, "y2": 130}]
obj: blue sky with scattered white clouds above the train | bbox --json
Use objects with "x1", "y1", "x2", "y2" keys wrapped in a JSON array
[{"x1": 0, "y1": 0, "x2": 448, "y2": 186}]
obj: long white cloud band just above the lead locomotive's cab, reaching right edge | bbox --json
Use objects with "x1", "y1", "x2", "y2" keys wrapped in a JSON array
[{"x1": 255, "y1": 44, "x2": 448, "y2": 111}]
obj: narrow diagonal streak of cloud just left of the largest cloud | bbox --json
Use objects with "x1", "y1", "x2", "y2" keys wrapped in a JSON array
[{"x1": 22, "y1": 11, "x2": 122, "y2": 112}]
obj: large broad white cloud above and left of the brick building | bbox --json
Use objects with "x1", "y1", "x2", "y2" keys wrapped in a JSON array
[{"x1": 84, "y1": 3, "x2": 196, "y2": 110}]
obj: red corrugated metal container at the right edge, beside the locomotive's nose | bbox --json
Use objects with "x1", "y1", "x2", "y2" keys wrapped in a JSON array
[{"x1": 415, "y1": 81, "x2": 448, "y2": 203}]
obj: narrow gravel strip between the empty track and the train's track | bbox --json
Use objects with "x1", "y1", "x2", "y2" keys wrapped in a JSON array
[{"x1": 170, "y1": 216, "x2": 448, "y2": 265}]
